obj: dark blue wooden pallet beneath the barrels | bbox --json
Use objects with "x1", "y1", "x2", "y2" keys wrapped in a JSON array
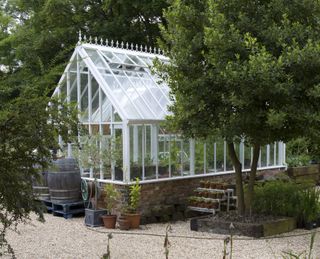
[{"x1": 41, "y1": 200, "x2": 85, "y2": 219}]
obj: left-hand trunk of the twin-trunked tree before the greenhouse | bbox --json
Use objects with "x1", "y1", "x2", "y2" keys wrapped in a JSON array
[{"x1": 228, "y1": 143, "x2": 245, "y2": 215}]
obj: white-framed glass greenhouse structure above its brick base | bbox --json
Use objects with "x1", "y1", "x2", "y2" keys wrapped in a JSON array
[{"x1": 53, "y1": 35, "x2": 285, "y2": 183}]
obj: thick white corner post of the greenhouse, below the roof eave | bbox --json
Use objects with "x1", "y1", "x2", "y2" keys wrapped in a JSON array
[{"x1": 122, "y1": 122, "x2": 131, "y2": 183}]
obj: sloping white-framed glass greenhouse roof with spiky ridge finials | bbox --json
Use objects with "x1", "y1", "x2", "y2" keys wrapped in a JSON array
[{"x1": 54, "y1": 36, "x2": 171, "y2": 123}]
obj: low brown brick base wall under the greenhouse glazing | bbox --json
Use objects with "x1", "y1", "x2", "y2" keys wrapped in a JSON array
[{"x1": 99, "y1": 169, "x2": 283, "y2": 224}]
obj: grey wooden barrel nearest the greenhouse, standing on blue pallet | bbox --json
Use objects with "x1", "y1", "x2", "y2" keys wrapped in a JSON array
[{"x1": 47, "y1": 158, "x2": 81, "y2": 203}]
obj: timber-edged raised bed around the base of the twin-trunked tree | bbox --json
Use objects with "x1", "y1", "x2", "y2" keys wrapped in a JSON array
[{"x1": 190, "y1": 213, "x2": 297, "y2": 238}]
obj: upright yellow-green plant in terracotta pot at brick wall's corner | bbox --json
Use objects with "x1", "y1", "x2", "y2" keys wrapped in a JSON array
[{"x1": 124, "y1": 178, "x2": 141, "y2": 228}]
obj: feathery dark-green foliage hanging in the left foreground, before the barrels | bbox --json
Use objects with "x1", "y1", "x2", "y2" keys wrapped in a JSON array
[{"x1": 0, "y1": 92, "x2": 77, "y2": 255}]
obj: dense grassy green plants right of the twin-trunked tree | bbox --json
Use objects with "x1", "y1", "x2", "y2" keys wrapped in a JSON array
[{"x1": 253, "y1": 180, "x2": 320, "y2": 224}]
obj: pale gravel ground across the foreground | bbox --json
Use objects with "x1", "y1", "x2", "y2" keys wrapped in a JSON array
[{"x1": 8, "y1": 214, "x2": 320, "y2": 259}]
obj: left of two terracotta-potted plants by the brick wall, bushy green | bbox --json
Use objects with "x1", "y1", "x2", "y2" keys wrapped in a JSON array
[{"x1": 101, "y1": 184, "x2": 120, "y2": 228}]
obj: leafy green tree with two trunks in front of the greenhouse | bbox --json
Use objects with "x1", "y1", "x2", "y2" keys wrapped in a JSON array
[{"x1": 158, "y1": 0, "x2": 320, "y2": 214}]
